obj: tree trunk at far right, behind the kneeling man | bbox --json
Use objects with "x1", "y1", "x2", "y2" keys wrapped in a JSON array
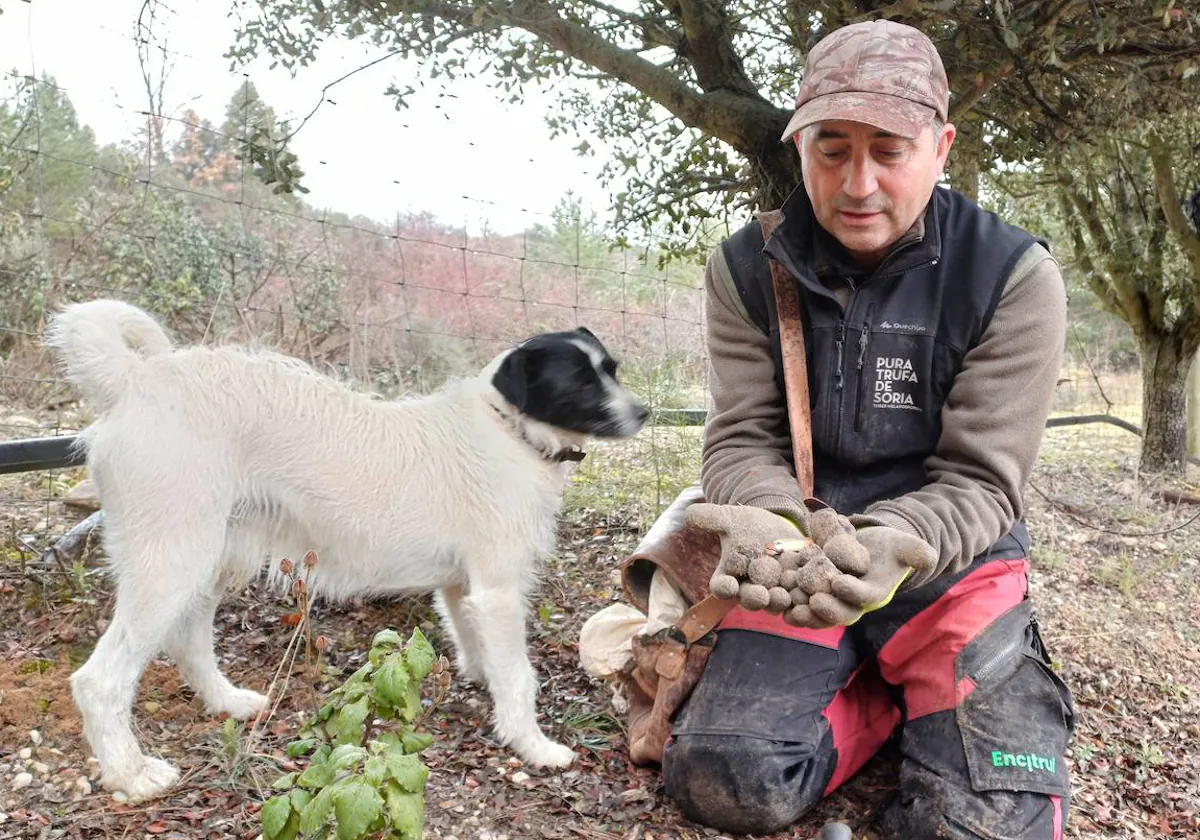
[{"x1": 1139, "y1": 332, "x2": 1194, "y2": 474}]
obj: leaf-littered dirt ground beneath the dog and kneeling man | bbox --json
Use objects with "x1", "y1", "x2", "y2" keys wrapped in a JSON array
[{"x1": 0, "y1": 415, "x2": 1200, "y2": 840}]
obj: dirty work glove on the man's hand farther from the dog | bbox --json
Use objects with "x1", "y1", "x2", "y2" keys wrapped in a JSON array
[{"x1": 806, "y1": 524, "x2": 937, "y2": 626}]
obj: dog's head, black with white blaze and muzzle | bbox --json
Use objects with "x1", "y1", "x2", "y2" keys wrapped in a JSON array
[{"x1": 492, "y1": 326, "x2": 649, "y2": 438}]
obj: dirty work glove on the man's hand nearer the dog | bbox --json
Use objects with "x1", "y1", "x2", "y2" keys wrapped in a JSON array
[{"x1": 684, "y1": 502, "x2": 800, "y2": 614}]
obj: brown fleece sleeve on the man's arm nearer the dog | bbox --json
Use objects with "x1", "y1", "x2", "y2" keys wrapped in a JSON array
[{"x1": 700, "y1": 242, "x2": 805, "y2": 522}]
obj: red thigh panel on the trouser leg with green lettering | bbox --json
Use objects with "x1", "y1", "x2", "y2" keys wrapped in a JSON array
[{"x1": 878, "y1": 560, "x2": 1030, "y2": 720}]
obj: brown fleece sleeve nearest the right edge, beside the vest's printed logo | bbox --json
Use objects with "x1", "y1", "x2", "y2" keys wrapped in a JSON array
[{"x1": 865, "y1": 245, "x2": 1067, "y2": 586}]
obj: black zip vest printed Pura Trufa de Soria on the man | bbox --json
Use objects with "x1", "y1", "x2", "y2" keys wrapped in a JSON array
[{"x1": 722, "y1": 185, "x2": 1036, "y2": 556}]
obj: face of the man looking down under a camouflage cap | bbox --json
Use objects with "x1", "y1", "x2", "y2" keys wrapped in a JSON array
[{"x1": 796, "y1": 120, "x2": 954, "y2": 266}]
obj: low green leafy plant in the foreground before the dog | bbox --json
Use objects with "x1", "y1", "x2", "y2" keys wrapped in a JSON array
[{"x1": 262, "y1": 629, "x2": 450, "y2": 840}]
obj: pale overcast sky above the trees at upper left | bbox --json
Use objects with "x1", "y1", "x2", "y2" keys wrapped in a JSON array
[{"x1": 0, "y1": 0, "x2": 607, "y2": 232}]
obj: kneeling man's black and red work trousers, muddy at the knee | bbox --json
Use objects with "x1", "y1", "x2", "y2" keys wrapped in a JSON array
[{"x1": 662, "y1": 558, "x2": 1074, "y2": 840}]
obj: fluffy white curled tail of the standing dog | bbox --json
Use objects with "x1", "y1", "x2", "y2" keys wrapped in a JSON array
[{"x1": 46, "y1": 300, "x2": 170, "y2": 412}]
